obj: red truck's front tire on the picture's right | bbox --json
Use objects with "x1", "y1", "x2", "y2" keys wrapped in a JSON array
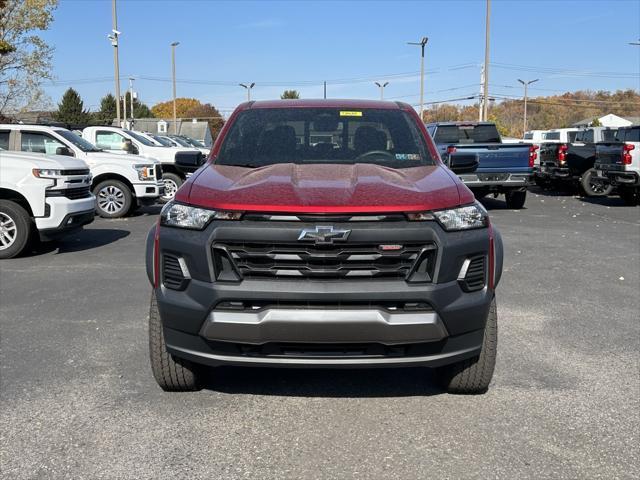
[{"x1": 436, "y1": 298, "x2": 498, "y2": 394}]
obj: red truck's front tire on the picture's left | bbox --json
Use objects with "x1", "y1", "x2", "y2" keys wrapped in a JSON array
[{"x1": 149, "y1": 292, "x2": 200, "y2": 392}]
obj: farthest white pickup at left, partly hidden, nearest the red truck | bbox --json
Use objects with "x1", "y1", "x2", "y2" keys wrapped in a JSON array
[{"x1": 82, "y1": 126, "x2": 204, "y2": 202}]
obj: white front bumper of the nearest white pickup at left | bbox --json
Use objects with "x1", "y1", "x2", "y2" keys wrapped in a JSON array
[{"x1": 35, "y1": 195, "x2": 96, "y2": 236}]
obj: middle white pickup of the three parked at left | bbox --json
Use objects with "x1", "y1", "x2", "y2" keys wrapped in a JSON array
[{"x1": 0, "y1": 124, "x2": 164, "y2": 218}]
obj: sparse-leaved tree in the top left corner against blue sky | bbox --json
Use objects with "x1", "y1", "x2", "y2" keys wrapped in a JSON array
[{"x1": 0, "y1": 0, "x2": 58, "y2": 113}]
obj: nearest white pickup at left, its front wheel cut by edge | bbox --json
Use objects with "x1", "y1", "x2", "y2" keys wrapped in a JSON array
[{"x1": 0, "y1": 151, "x2": 96, "y2": 259}]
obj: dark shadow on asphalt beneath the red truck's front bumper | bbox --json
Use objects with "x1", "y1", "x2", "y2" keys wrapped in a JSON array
[{"x1": 205, "y1": 367, "x2": 444, "y2": 398}]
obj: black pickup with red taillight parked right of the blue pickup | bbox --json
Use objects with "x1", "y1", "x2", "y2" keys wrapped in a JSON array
[{"x1": 537, "y1": 127, "x2": 617, "y2": 197}]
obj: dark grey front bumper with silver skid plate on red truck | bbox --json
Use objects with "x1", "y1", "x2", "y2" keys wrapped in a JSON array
[{"x1": 147, "y1": 218, "x2": 502, "y2": 367}]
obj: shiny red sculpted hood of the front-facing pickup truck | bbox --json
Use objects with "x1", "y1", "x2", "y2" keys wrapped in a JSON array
[{"x1": 176, "y1": 163, "x2": 464, "y2": 213}]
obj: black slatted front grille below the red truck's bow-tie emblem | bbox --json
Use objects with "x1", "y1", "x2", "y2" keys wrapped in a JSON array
[{"x1": 213, "y1": 243, "x2": 436, "y2": 282}]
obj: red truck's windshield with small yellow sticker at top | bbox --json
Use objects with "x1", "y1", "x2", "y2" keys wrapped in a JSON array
[{"x1": 216, "y1": 108, "x2": 434, "y2": 168}]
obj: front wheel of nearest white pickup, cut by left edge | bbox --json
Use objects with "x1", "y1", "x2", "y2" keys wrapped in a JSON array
[{"x1": 0, "y1": 200, "x2": 33, "y2": 258}]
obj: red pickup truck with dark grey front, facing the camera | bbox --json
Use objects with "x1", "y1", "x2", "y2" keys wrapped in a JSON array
[{"x1": 146, "y1": 100, "x2": 503, "y2": 393}]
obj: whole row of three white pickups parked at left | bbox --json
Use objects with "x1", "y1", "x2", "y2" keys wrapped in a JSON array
[{"x1": 0, "y1": 124, "x2": 204, "y2": 258}]
